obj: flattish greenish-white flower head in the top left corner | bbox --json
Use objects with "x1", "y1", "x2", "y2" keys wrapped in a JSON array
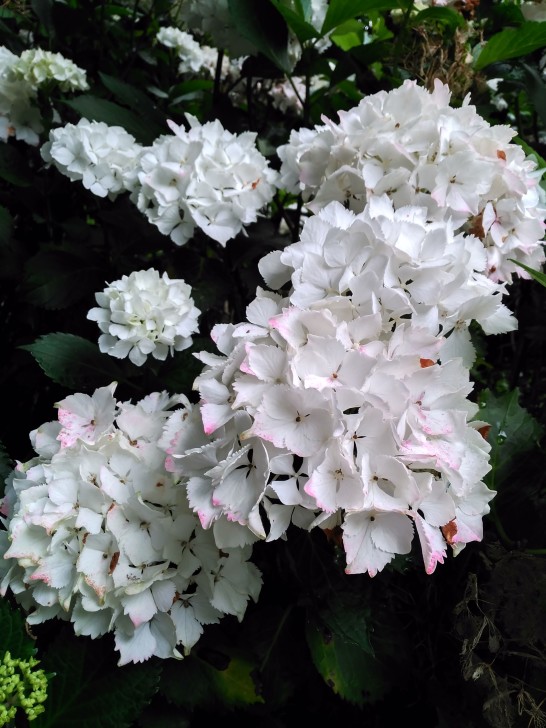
[{"x1": 12, "y1": 48, "x2": 89, "y2": 91}]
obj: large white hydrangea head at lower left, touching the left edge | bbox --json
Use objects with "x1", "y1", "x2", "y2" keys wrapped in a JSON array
[{"x1": 0, "y1": 385, "x2": 261, "y2": 665}]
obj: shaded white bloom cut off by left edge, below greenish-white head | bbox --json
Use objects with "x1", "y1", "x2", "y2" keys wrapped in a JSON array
[{"x1": 0, "y1": 46, "x2": 43, "y2": 145}]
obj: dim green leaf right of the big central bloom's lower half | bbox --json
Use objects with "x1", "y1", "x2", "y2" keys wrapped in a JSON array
[{"x1": 479, "y1": 389, "x2": 543, "y2": 490}]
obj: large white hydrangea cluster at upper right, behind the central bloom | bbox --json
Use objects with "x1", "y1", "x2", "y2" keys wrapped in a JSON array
[{"x1": 278, "y1": 81, "x2": 546, "y2": 282}]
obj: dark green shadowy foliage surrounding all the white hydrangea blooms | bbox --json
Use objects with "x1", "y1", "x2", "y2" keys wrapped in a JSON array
[{"x1": 0, "y1": 0, "x2": 546, "y2": 728}]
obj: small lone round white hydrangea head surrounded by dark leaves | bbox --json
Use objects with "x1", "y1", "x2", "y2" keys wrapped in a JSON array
[{"x1": 87, "y1": 268, "x2": 201, "y2": 366}]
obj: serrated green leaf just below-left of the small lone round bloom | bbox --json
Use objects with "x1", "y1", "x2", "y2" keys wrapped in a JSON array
[{"x1": 19, "y1": 333, "x2": 124, "y2": 389}]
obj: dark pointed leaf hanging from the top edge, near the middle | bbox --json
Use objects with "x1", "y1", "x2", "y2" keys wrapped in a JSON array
[{"x1": 228, "y1": 0, "x2": 291, "y2": 73}]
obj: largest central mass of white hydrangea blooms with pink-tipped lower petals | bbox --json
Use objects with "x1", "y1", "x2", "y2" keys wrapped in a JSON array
[{"x1": 155, "y1": 198, "x2": 496, "y2": 576}]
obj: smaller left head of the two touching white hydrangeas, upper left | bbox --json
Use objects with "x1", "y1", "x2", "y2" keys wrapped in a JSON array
[{"x1": 41, "y1": 119, "x2": 142, "y2": 200}]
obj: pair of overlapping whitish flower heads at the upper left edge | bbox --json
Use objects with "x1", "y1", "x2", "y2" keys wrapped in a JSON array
[{"x1": 0, "y1": 46, "x2": 89, "y2": 145}]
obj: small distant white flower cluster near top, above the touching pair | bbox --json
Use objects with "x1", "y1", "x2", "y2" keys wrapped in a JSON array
[{"x1": 156, "y1": 27, "x2": 241, "y2": 82}]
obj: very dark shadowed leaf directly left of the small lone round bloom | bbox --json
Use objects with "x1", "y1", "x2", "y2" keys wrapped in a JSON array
[{"x1": 24, "y1": 251, "x2": 101, "y2": 310}]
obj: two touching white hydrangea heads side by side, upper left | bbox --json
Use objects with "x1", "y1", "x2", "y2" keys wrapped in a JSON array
[{"x1": 41, "y1": 114, "x2": 278, "y2": 246}]
